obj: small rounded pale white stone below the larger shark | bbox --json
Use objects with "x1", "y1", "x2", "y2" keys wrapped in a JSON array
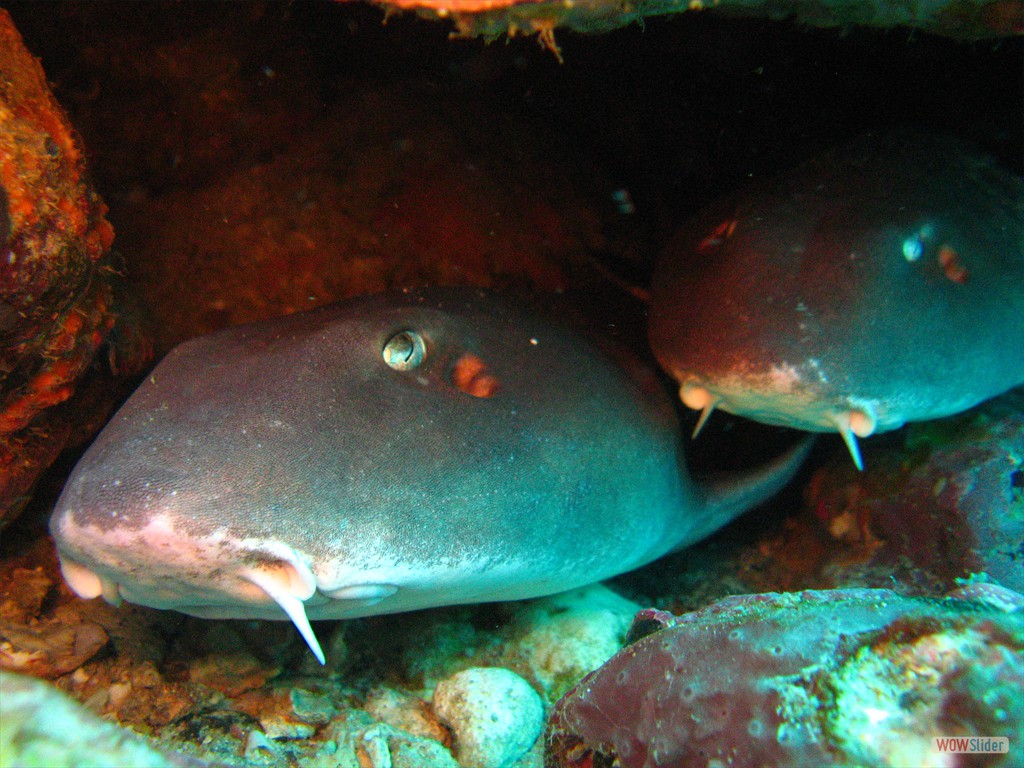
[{"x1": 433, "y1": 667, "x2": 544, "y2": 768}]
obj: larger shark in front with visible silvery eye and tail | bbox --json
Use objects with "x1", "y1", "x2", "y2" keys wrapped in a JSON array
[{"x1": 50, "y1": 289, "x2": 802, "y2": 660}]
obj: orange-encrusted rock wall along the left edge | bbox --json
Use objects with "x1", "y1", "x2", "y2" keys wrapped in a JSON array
[{"x1": 0, "y1": 10, "x2": 147, "y2": 526}]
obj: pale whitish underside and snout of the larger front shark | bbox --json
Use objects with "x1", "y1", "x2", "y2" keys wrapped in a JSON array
[{"x1": 54, "y1": 512, "x2": 569, "y2": 664}]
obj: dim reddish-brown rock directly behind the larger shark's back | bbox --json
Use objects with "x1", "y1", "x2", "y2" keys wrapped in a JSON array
[{"x1": 110, "y1": 85, "x2": 603, "y2": 354}]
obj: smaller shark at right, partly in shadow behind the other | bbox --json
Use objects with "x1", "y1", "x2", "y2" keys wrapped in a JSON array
[{"x1": 649, "y1": 132, "x2": 1024, "y2": 467}]
